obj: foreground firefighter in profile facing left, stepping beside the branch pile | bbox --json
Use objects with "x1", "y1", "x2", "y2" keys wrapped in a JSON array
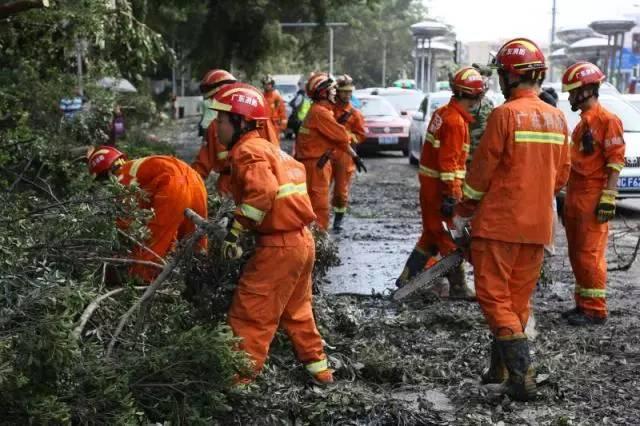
[{"x1": 213, "y1": 83, "x2": 333, "y2": 384}]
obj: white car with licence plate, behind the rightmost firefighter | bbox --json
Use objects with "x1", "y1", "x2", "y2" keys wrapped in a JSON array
[{"x1": 558, "y1": 91, "x2": 640, "y2": 198}]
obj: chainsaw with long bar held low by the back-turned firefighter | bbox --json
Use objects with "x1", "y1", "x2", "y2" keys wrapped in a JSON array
[{"x1": 393, "y1": 222, "x2": 471, "y2": 302}]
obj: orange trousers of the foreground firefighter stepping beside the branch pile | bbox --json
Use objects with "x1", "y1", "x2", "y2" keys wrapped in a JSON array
[{"x1": 228, "y1": 228, "x2": 326, "y2": 373}]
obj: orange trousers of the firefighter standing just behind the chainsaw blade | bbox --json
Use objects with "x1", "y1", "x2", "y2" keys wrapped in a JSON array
[{"x1": 416, "y1": 176, "x2": 456, "y2": 256}]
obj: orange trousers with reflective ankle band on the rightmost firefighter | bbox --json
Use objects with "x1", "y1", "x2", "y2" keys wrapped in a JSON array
[{"x1": 564, "y1": 181, "x2": 609, "y2": 317}]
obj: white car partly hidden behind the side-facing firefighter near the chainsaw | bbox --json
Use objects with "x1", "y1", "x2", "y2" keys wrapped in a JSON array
[{"x1": 409, "y1": 90, "x2": 504, "y2": 165}]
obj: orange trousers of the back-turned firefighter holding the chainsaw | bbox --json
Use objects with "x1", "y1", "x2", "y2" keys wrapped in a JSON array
[{"x1": 471, "y1": 238, "x2": 544, "y2": 336}]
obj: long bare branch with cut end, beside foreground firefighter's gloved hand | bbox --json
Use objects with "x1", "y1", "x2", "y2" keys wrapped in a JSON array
[{"x1": 106, "y1": 209, "x2": 218, "y2": 358}]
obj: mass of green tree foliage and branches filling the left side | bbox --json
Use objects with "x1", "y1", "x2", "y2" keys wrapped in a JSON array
[{"x1": 0, "y1": 0, "x2": 245, "y2": 424}]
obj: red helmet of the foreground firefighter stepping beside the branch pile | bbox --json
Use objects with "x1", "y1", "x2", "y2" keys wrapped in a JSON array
[{"x1": 211, "y1": 83, "x2": 270, "y2": 121}]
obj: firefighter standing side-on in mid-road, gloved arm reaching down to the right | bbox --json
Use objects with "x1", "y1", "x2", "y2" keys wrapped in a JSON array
[{"x1": 295, "y1": 73, "x2": 366, "y2": 230}]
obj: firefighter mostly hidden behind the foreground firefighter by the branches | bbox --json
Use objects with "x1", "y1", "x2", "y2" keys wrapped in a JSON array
[{"x1": 191, "y1": 69, "x2": 280, "y2": 196}]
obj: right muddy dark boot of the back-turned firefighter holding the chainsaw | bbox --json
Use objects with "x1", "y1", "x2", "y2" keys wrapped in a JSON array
[{"x1": 496, "y1": 335, "x2": 536, "y2": 401}]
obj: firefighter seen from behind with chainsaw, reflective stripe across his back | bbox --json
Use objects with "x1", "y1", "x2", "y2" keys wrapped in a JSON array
[{"x1": 453, "y1": 38, "x2": 570, "y2": 400}]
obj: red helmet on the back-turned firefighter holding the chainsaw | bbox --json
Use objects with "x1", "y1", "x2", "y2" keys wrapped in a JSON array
[{"x1": 493, "y1": 38, "x2": 547, "y2": 79}]
